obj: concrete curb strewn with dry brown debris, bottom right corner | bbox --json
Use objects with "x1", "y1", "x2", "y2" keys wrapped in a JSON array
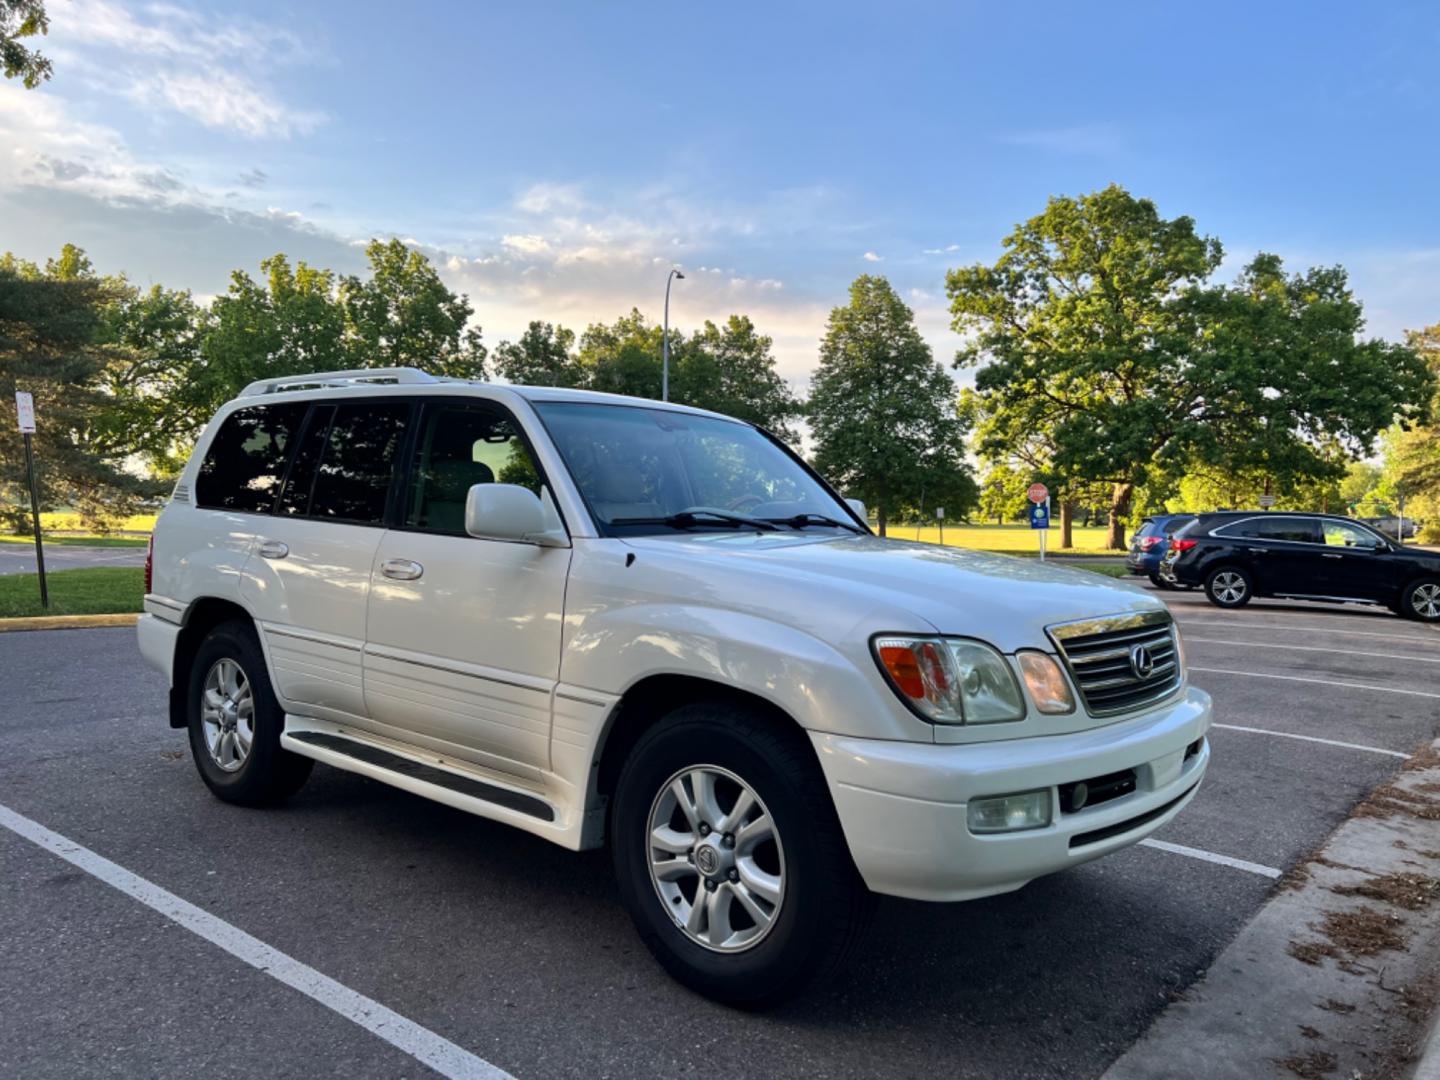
[{"x1": 1103, "y1": 740, "x2": 1440, "y2": 1080}]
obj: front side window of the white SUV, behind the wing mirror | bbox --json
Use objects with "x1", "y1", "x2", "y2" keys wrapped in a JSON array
[{"x1": 405, "y1": 403, "x2": 540, "y2": 536}]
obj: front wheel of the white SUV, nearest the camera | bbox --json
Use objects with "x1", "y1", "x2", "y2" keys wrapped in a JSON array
[{"x1": 611, "y1": 703, "x2": 871, "y2": 1008}]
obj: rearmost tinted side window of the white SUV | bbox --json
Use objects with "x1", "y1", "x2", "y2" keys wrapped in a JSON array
[{"x1": 194, "y1": 403, "x2": 310, "y2": 514}]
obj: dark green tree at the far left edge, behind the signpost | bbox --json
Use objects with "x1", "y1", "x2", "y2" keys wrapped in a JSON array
[{"x1": 0, "y1": 245, "x2": 153, "y2": 528}]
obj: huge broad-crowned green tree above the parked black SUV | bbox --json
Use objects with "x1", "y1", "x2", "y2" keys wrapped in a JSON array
[{"x1": 946, "y1": 186, "x2": 1428, "y2": 549}]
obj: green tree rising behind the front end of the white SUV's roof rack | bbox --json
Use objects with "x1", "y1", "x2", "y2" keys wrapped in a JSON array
[{"x1": 340, "y1": 240, "x2": 485, "y2": 379}]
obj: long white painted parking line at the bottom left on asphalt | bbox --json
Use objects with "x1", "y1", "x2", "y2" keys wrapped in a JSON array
[{"x1": 0, "y1": 805, "x2": 513, "y2": 1080}]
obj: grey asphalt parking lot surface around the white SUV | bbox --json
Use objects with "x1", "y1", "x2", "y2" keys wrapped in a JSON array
[{"x1": 0, "y1": 593, "x2": 1440, "y2": 1080}]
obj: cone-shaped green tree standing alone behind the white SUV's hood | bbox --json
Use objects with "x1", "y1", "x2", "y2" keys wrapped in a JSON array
[{"x1": 808, "y1": 275, "x2": 969, "y2": 536}]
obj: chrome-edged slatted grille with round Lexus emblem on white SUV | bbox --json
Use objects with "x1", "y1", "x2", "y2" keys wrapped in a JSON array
[{"x1": 1045, "y1": 611, "x2": 1184, "y2": 716}]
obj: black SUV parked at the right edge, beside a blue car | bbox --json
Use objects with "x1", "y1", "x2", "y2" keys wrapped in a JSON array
[{"x1": 1159, "y1": 510, "x2": 1440, "y2": 622}]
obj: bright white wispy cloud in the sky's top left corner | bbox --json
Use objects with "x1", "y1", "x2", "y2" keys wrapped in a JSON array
[{"x1": 52, "y1": 0, "x2": 325, "y2": 138}]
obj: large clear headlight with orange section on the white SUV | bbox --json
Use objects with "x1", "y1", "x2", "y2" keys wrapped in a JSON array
[{"x1": 874, "y1": 635, "x2": 1025, "y2": 724}]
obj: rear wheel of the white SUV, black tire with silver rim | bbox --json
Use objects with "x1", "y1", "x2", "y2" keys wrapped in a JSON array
[{"x1": 186, "y1": 619, "x2": 314, "y2": 806}]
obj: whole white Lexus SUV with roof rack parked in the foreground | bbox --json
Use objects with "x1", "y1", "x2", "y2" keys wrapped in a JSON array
[{"x1": 138, "y1": 369, "x2": 1210, "y2": 1007}]
